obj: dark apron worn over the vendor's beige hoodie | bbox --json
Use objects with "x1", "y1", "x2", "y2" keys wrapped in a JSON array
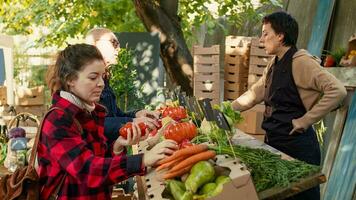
[{"x1": 262, "y1": 47, "x2": 320, "y2": 164}]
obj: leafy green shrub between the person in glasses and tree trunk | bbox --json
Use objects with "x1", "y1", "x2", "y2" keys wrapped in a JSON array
[{"x1": 110, "y1": 48, "x2": 145, "y2": 112}]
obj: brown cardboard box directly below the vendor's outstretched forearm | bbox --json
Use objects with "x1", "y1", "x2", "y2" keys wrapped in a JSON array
[{"x1": 237, "y1": 104, "x2": 265, "y2": 135}]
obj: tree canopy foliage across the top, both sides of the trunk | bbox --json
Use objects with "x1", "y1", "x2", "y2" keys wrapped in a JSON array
[{"x1": 0, "y1": 0, "x2": 282, "y2": 46}]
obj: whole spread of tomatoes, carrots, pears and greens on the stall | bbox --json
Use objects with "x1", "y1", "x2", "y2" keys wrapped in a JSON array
[{"x1": 140, "y1": 99, "x2": 320, "y2": 200}]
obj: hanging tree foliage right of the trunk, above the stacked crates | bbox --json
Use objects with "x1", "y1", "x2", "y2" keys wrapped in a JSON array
[{"x1": 178, "y1": 0, "x2": 282, "y2": 46}]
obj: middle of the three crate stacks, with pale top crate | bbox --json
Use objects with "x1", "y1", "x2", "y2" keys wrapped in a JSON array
[{"x1": 224, "y1": 36, "x2": 251, "y2": 101}]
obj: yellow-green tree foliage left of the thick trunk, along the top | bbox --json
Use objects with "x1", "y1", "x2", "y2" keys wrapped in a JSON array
[{"x1": 0, "y1": 0, "x2": 144, "y2": 46}]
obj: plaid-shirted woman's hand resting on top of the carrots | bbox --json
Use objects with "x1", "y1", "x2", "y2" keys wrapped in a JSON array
[{"x1": 143, "y1": 140, "x2": 178, "y2": 167}]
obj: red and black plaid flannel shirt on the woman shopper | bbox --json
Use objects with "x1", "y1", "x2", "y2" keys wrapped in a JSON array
[{"x1": 37, "y1": 92, "x2": 146, "y2": 200}]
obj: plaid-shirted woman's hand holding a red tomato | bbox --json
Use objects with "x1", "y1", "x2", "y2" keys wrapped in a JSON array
[{"x1": 113, "y1": 122, "x2": 142, "y2": 154}]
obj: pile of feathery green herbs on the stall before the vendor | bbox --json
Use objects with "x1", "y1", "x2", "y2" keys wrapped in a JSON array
[{"x1": 211, "y1": 146, "x2": 320, "y2": 192}]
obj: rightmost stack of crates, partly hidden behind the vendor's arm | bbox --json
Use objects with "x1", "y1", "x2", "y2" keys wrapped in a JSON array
[{"x1": 237, "y1": 38, "x2": 272, "y2": 140}]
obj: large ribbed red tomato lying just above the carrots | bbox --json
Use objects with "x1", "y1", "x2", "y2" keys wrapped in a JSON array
[{"x1": 163, "y1": 122, "x2": 197, "y2": 144}]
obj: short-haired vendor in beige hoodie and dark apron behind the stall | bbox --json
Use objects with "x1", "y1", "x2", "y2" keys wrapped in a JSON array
[{"x1": 232, "y1": 12, "x2": 346, "y2": 200}]
